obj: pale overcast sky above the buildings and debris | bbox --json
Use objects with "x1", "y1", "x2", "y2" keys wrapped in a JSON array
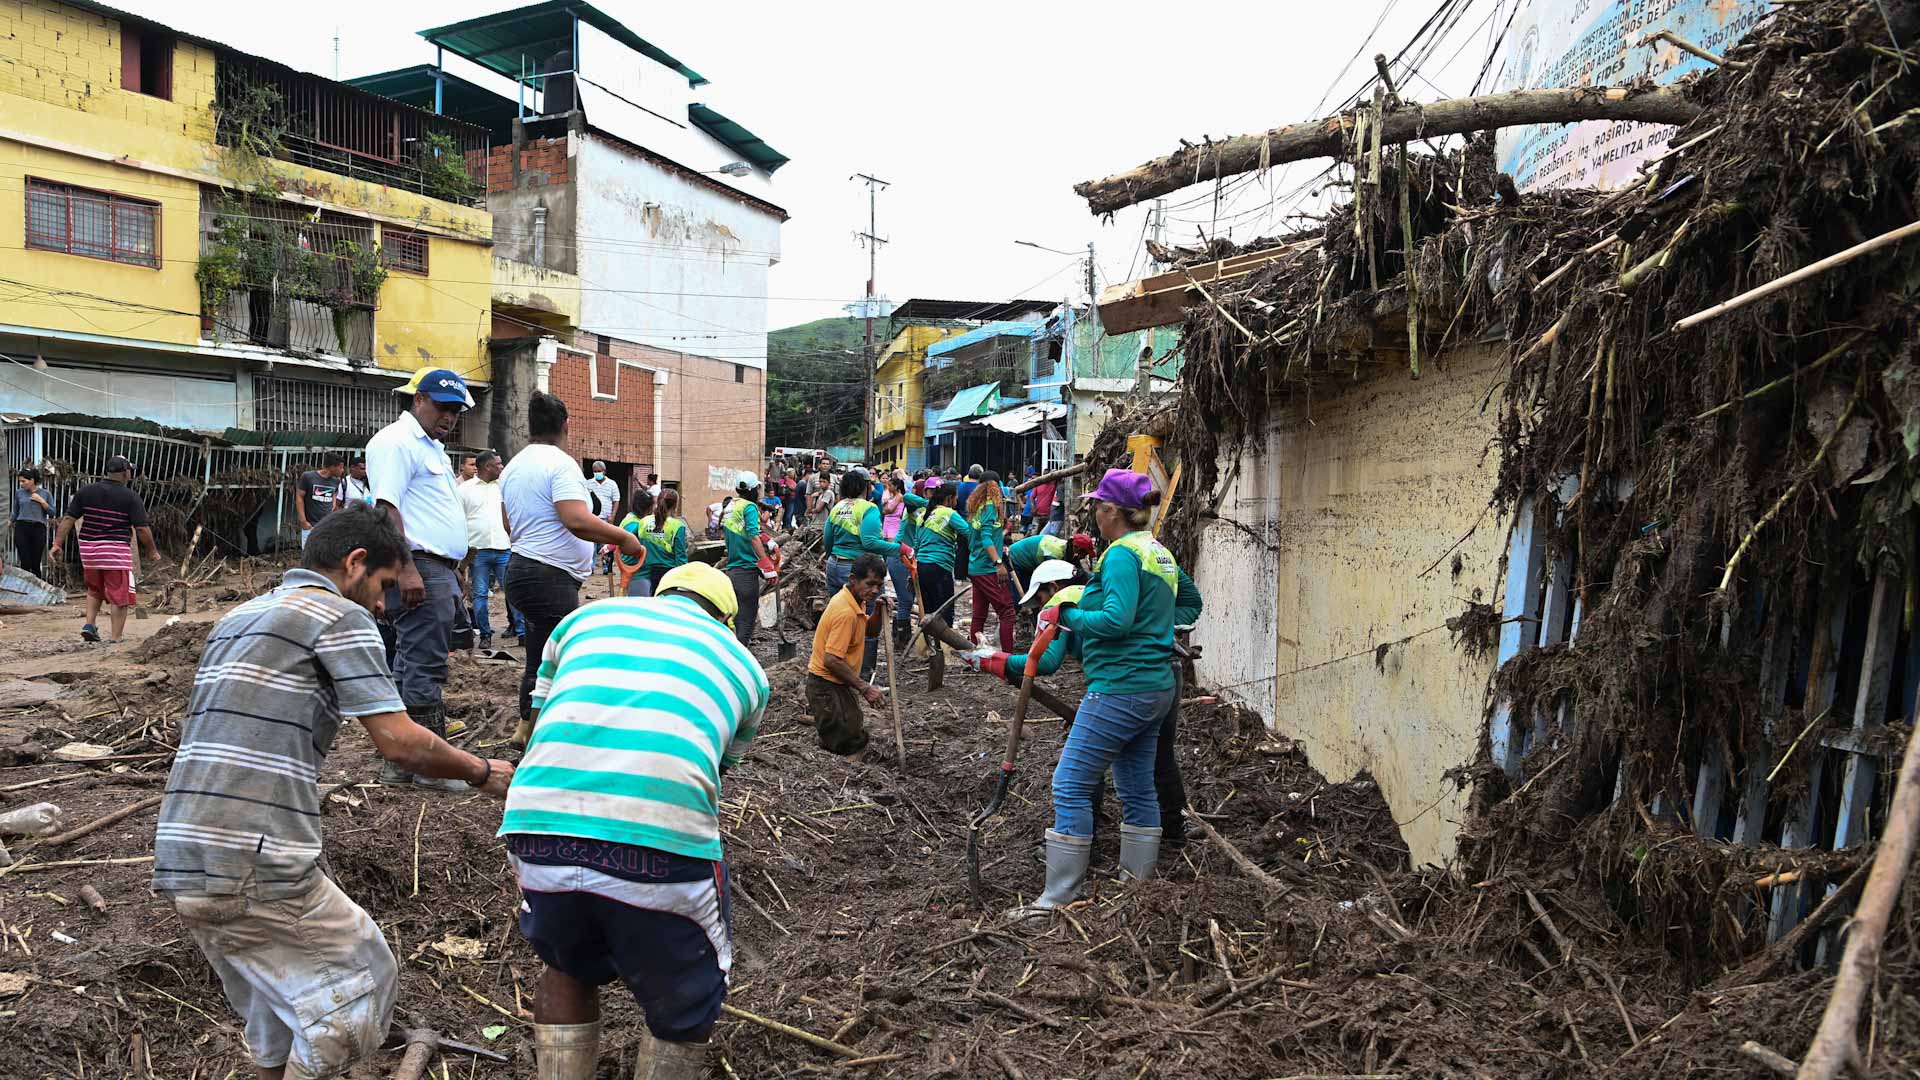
[{"x1": 142, "y1": 0, "x2": 1511, "y2": 327}]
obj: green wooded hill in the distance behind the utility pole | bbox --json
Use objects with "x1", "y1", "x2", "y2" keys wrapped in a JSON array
[{"x1": 766, "y1": 317, "x2": 883, "y2": 450}]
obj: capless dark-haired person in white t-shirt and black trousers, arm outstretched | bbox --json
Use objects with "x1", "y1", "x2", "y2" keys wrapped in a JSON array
[{"x1": 499, "y1": 392, "x2": 641, "y2": 746}]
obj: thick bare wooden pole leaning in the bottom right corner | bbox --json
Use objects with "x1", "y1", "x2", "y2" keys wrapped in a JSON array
[{"x1": 1799, "y1": 711, "x2": 1920, "y2": 1080}]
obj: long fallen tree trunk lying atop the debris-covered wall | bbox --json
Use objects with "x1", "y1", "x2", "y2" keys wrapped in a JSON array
[{"x1": 1073, "y1": 83, "x2": 1701, "y2": 213}]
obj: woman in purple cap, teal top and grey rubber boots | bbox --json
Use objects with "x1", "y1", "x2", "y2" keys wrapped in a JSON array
[{"x1": 1008, "y1": 469, "x2": 1181, "y2": 919}]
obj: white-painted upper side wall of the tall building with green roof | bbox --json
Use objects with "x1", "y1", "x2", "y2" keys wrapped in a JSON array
[{"x1": 572, "y1": 131, "x2": 780, "y2": 367}]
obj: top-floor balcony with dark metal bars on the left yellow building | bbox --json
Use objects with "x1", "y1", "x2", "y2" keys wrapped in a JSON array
[{"x1": 213, "y1": 54, "x2": 488, "y2": 206}]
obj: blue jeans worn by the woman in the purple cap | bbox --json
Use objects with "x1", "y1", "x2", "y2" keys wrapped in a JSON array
[{"x1": 1054, "y1": 688, "x2": 1177, "y2": 836}]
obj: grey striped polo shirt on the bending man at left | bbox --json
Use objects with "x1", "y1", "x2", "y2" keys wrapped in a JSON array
[{"x1": 154, "y1": 571, "x2": 405, "y2": 899}]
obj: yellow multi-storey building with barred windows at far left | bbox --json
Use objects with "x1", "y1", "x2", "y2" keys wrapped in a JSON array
[{"x1": 0, "y1": 0, "x2": 493, "y2": 442}]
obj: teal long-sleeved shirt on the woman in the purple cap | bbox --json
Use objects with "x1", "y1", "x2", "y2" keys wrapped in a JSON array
[{"x1": 1060, "y1": 532, "x2": 1181, "y2": 694}]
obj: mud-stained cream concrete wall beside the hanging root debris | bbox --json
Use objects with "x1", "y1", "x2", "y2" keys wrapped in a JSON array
[{"x1": 1198, "y1": 340, "x2": 1507, "y2": 863}]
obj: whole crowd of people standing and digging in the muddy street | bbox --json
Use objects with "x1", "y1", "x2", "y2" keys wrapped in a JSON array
[{"x1": 15, "y1": 369, "x2": 1200, "y2": 1080}]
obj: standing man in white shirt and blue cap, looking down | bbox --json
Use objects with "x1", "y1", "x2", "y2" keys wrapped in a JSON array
[{"x1": 367, "y1": 367, "x2": 474, "y2": 792}]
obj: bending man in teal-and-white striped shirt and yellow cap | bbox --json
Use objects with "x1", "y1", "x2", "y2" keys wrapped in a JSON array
[{"x1": 499, "y1": 563, "x2": 770, "y2": 1080}]
